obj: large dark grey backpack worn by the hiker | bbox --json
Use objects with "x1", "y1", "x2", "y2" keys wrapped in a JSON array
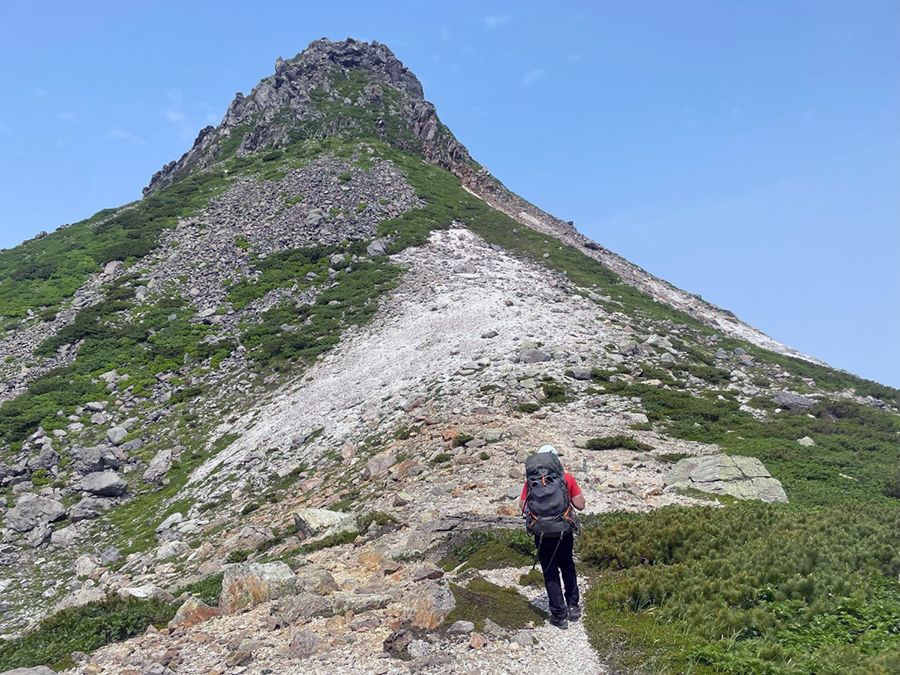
[{"x1": 525, "y1": 452, "x2": 576, "y2": 539}]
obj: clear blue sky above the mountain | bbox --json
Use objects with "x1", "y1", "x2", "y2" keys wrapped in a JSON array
[{"x1": 0, "y1": 0, "x2": 900, "y2": 385}]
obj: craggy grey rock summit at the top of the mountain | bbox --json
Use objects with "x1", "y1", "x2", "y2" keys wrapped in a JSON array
[{"x1": 144, "y1": 38, "x2": 473, "y2": 196}]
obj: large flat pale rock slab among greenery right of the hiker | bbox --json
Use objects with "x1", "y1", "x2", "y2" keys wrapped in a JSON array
[{"x1": 665, "y1": 455, "x2": 788, "y2": 503}]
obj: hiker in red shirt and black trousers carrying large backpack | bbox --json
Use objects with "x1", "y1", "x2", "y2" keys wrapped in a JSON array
[{"x1": 519, "y1": 445, "x2": 584, "y2": 630}]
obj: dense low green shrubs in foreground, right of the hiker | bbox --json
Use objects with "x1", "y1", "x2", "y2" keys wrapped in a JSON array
[{"x1": 580, "y1": 503, "x2": 900, "y2": 673}]
